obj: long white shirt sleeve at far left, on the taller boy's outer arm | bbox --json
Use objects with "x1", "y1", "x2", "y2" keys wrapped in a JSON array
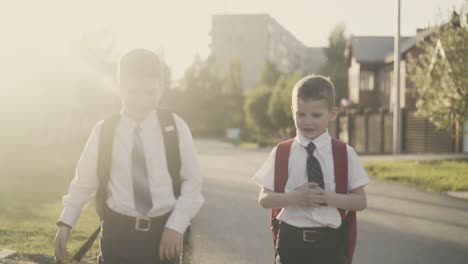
[{"x1": 59, "y1": 121, "x2": 103, "y2": 227}]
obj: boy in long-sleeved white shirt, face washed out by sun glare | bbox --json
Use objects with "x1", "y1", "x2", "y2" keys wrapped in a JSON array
[{"x1": 55, "y1": 49, "x2": 204, "y2": 264}]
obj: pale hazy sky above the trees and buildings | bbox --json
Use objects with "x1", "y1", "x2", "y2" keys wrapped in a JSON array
[{"x1": 0, "y1": 0, "x2": 468, "y2": 79}]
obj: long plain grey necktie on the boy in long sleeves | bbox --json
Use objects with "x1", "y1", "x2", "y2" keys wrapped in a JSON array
[{"x1": 132, "y1": 126, "x2": 153, "y2": 216}]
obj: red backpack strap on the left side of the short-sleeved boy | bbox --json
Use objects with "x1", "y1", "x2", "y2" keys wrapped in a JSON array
[{"x1": 270, "y1": 138, "x2": 294, "y2": 248}]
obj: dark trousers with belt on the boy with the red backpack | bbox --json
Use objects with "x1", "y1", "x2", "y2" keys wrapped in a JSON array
[{"x1": 276, "y1": 222, "x2": 347, "y2": 264}]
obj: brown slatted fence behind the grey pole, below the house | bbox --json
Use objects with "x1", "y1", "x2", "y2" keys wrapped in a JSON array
[{"x1": 329, "y1": 111, "x2": 454, "y2": 154}]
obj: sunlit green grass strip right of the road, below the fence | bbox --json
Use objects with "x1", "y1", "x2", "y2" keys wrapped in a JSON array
[{"x1": 364, "y1": 160, "x2": 468, "y2": 192}]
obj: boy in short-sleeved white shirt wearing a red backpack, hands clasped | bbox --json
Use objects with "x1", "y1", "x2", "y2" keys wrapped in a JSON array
[{"x1": 254, "y1": 75, "x2": 369, "y2": 264}]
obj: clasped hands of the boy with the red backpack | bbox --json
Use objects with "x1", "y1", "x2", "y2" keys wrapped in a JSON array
[{"x1": 291, "y1": 182, "x2": 326, "y2": 207}]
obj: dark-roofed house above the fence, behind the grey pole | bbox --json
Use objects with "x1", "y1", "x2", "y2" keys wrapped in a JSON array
[{"x1": 347, "y1": 30, "x2": 431, "y2": 110}]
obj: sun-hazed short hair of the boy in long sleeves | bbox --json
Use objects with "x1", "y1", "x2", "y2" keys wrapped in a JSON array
[{"x1": 118, "y1": 49, "x2": 162, "y2": 82}]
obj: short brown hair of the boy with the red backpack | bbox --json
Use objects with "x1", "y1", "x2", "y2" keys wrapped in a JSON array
[{"x1": 292, "y1": 75, "x2": 335, "y2": 109}]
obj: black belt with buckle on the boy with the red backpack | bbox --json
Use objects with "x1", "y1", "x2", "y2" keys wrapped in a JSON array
[{"x1": 279, "y1": 222, "x2": 342, "y2": 242}]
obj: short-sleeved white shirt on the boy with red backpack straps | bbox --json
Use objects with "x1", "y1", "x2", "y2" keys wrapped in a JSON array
[{"x1": 254, "y1": 131, "x2": 369, "y2": 228}]
